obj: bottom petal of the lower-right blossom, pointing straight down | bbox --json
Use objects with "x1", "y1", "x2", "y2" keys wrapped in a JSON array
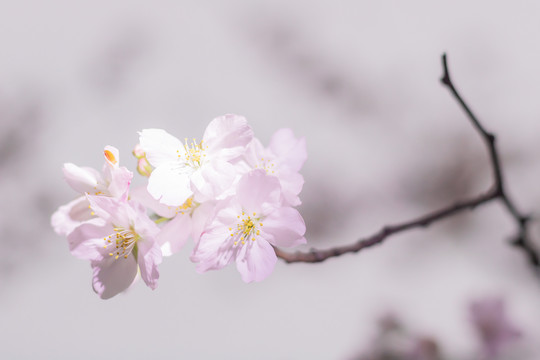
[{"x1": 236, "y1": 238, "x2": 277, "y2": 282}]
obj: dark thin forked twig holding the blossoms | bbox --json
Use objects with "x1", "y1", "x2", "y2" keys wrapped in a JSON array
[{"x1": 275, "y1": 54, "x2": 540, "y2": 268}]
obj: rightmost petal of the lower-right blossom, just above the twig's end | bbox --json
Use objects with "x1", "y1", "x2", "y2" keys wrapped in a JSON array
[{"x1": 262, "y1": 207, "x2": 306, "y2": 247}]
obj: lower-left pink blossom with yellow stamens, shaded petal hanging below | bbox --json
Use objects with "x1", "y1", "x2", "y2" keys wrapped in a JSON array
[{"x1": 68, "y1": 195, "x2": 162, "y2": 299}]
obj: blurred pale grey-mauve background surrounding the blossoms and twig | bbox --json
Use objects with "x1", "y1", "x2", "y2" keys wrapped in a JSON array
[{"x1": 0, "y1": 0, "x2": 540, "y2": 360}]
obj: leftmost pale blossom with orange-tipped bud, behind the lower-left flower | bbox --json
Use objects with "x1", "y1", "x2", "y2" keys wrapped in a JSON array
[{"x1": 51, "y1": 146, "x2": 133, "y2": 236}]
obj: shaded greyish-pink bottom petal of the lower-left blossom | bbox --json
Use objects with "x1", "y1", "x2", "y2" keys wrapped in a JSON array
[{"x1": 92, "y1": 255, "x2": 137, "y2": 299}]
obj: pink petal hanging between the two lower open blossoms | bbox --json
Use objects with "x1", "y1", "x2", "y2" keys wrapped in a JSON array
[{"x1": 156, "y1": 214, "x2": 192, "y2": 256}]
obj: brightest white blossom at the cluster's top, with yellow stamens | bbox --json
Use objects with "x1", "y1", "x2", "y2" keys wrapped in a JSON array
[{"x1": 140, "y1": 115, "x2": 253, "y2": 206}]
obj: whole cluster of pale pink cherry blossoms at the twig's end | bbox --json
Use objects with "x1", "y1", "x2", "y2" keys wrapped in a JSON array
[{"x1": 51, "y1": 114, "x2": 307, "y2": 299}]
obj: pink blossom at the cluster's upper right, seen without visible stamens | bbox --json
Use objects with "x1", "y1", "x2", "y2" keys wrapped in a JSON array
[{"x1": 244, "y1": 128, "x2": 307, "y2": 206}]
